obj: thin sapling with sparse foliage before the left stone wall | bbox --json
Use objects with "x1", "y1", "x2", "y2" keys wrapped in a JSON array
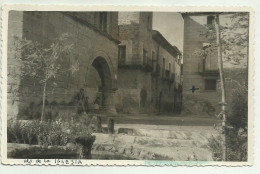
[{"x1": 12, "y1": 34, "x2": 79, "y2": 121}]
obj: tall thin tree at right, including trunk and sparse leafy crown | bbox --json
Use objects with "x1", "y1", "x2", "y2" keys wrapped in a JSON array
[{"x1": 195, "y1": 12, "x2": 249, "y2": 160}]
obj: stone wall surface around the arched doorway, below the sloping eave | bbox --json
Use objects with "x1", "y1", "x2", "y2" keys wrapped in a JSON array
[{"x1": 8, "y1": 11, "x2": 119, "y2": 119}]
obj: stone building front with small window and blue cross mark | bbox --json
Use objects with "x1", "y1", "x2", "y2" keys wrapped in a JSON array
[{"x1": 182, "y1": 13, "x2": 221, "y2": 115}]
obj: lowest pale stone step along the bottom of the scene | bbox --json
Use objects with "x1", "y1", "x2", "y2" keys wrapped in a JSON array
[{"x1": 93, "y1": 144, "x2": 213, "y2": 161}]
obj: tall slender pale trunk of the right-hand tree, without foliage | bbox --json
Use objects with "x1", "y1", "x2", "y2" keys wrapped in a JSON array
[{"x1": 215, "y1": 13, "x2": 227, "y2": 161}]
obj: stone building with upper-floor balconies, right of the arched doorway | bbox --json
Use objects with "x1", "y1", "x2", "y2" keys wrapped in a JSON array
[{"x1": 116, "y1": 12, "x2": 182, "y2": 113}]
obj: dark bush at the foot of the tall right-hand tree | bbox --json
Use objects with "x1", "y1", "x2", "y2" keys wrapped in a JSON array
[{"x1": 208, "y1": 87, "x2": 248, "y2": 161}]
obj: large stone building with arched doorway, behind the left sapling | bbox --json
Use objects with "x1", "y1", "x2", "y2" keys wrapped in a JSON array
[{"x1": 8, "y1": 11, "x2": 120, "y2": 117}]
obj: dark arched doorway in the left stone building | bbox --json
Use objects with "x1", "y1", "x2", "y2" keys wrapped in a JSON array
[{"x1": 90, "y1": 57, "x2": 116, "y2": 114}]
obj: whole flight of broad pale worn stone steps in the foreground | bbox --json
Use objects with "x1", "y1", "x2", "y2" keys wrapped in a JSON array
[{"x1": 94, "y1": 128, "x2": 220, "y2": 161}]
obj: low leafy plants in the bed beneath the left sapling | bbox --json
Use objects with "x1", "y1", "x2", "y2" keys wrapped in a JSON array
[{"x1": 7, "y1": 115, "x2": 91, "y2": 146}]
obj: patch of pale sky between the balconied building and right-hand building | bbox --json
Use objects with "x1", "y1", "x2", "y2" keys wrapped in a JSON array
[{"x1": 153, "y1": 12, "x2": 184, "y2": 51}]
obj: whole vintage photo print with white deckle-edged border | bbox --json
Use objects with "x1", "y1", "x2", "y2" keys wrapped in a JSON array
[{"x1": 1, "y1": 5, "x2": 254, "y2": 166}]
